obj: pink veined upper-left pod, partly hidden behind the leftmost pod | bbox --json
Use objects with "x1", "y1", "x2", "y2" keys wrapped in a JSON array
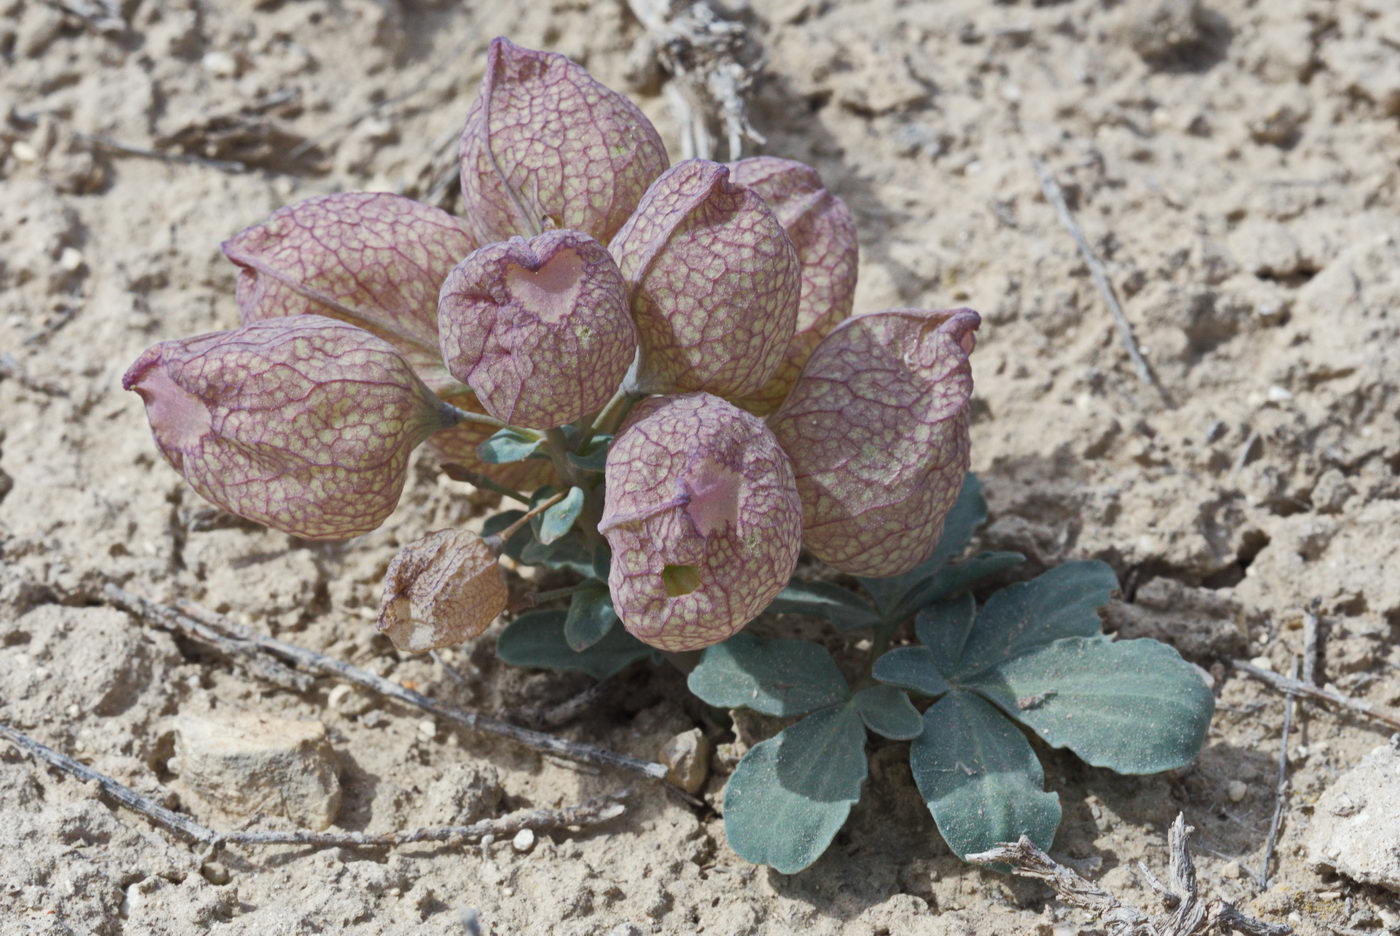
[{"x1": 224, "y1": 192, "x2": 549, "y2": 487}]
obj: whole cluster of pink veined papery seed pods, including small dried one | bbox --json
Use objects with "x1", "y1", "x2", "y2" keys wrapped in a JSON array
[{"x1": 123, "y1": 39, "x2": 979, "y2": 651}]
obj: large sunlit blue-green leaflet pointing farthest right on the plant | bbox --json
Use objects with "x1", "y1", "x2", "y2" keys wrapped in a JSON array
[{"x1": 965, "y1": 637, "x2": 1215, "y2": 774}]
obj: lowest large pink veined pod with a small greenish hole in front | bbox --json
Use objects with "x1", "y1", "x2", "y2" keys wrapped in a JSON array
[{"x1": 598, "y1": 393, "x2": 802, "y2": 651}]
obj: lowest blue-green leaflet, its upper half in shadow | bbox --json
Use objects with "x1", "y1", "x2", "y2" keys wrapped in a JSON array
[{"x1": 724, "y1": 704, "x2": 869, "y2": 874}]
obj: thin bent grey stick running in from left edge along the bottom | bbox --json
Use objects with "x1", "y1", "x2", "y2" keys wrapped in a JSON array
[{"x1": 0, "y1": 723, "x2": 627, "y2": 848}]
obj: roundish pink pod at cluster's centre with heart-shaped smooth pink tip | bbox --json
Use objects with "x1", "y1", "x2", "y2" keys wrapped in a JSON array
[{"x1": 438, "y1": 231, "x2": 637, "y2": 430}]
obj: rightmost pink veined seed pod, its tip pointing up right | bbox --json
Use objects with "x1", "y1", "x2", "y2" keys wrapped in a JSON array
[{"x1": 769, "y1": 309, "x2": 981, "y2": 578}]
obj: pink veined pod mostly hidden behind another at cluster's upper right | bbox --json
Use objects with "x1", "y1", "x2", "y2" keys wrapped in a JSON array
[{"x1": 729, "y1": 157, "x2": 858, "y2": 416}]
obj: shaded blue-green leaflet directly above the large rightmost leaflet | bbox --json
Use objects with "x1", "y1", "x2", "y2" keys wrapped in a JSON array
[{"x1": 956, "y1": 561, "x2": 1119, "y2": 679}]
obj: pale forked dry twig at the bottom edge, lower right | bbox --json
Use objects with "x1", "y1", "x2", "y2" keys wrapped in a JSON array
[{"x1": 967, "y1": 814, "x2": 1294, "y2": 936}]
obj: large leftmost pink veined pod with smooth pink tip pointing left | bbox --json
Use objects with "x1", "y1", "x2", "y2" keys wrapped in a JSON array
[{"x1": 122, "y1": 315, "x2": 455, "y2": 540}]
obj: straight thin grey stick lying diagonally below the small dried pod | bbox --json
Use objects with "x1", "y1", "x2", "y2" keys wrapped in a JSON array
[{"x1": 153, "y1": 602, "x2": 669, "y2": 786}]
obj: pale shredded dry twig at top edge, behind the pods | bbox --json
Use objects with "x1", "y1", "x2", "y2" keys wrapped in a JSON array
[{"x1": 627, "y1": 0, "x2": 763, "y2": 161}]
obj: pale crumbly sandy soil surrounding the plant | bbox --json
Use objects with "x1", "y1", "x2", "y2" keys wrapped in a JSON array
[{"x1": 0, "y1": 0, "x2": 1400, "y2": 936}]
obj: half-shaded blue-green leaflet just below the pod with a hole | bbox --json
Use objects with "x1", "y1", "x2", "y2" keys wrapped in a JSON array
[{"x1": 686, "y1": 631, "x2": 851, "y2": 716}]
